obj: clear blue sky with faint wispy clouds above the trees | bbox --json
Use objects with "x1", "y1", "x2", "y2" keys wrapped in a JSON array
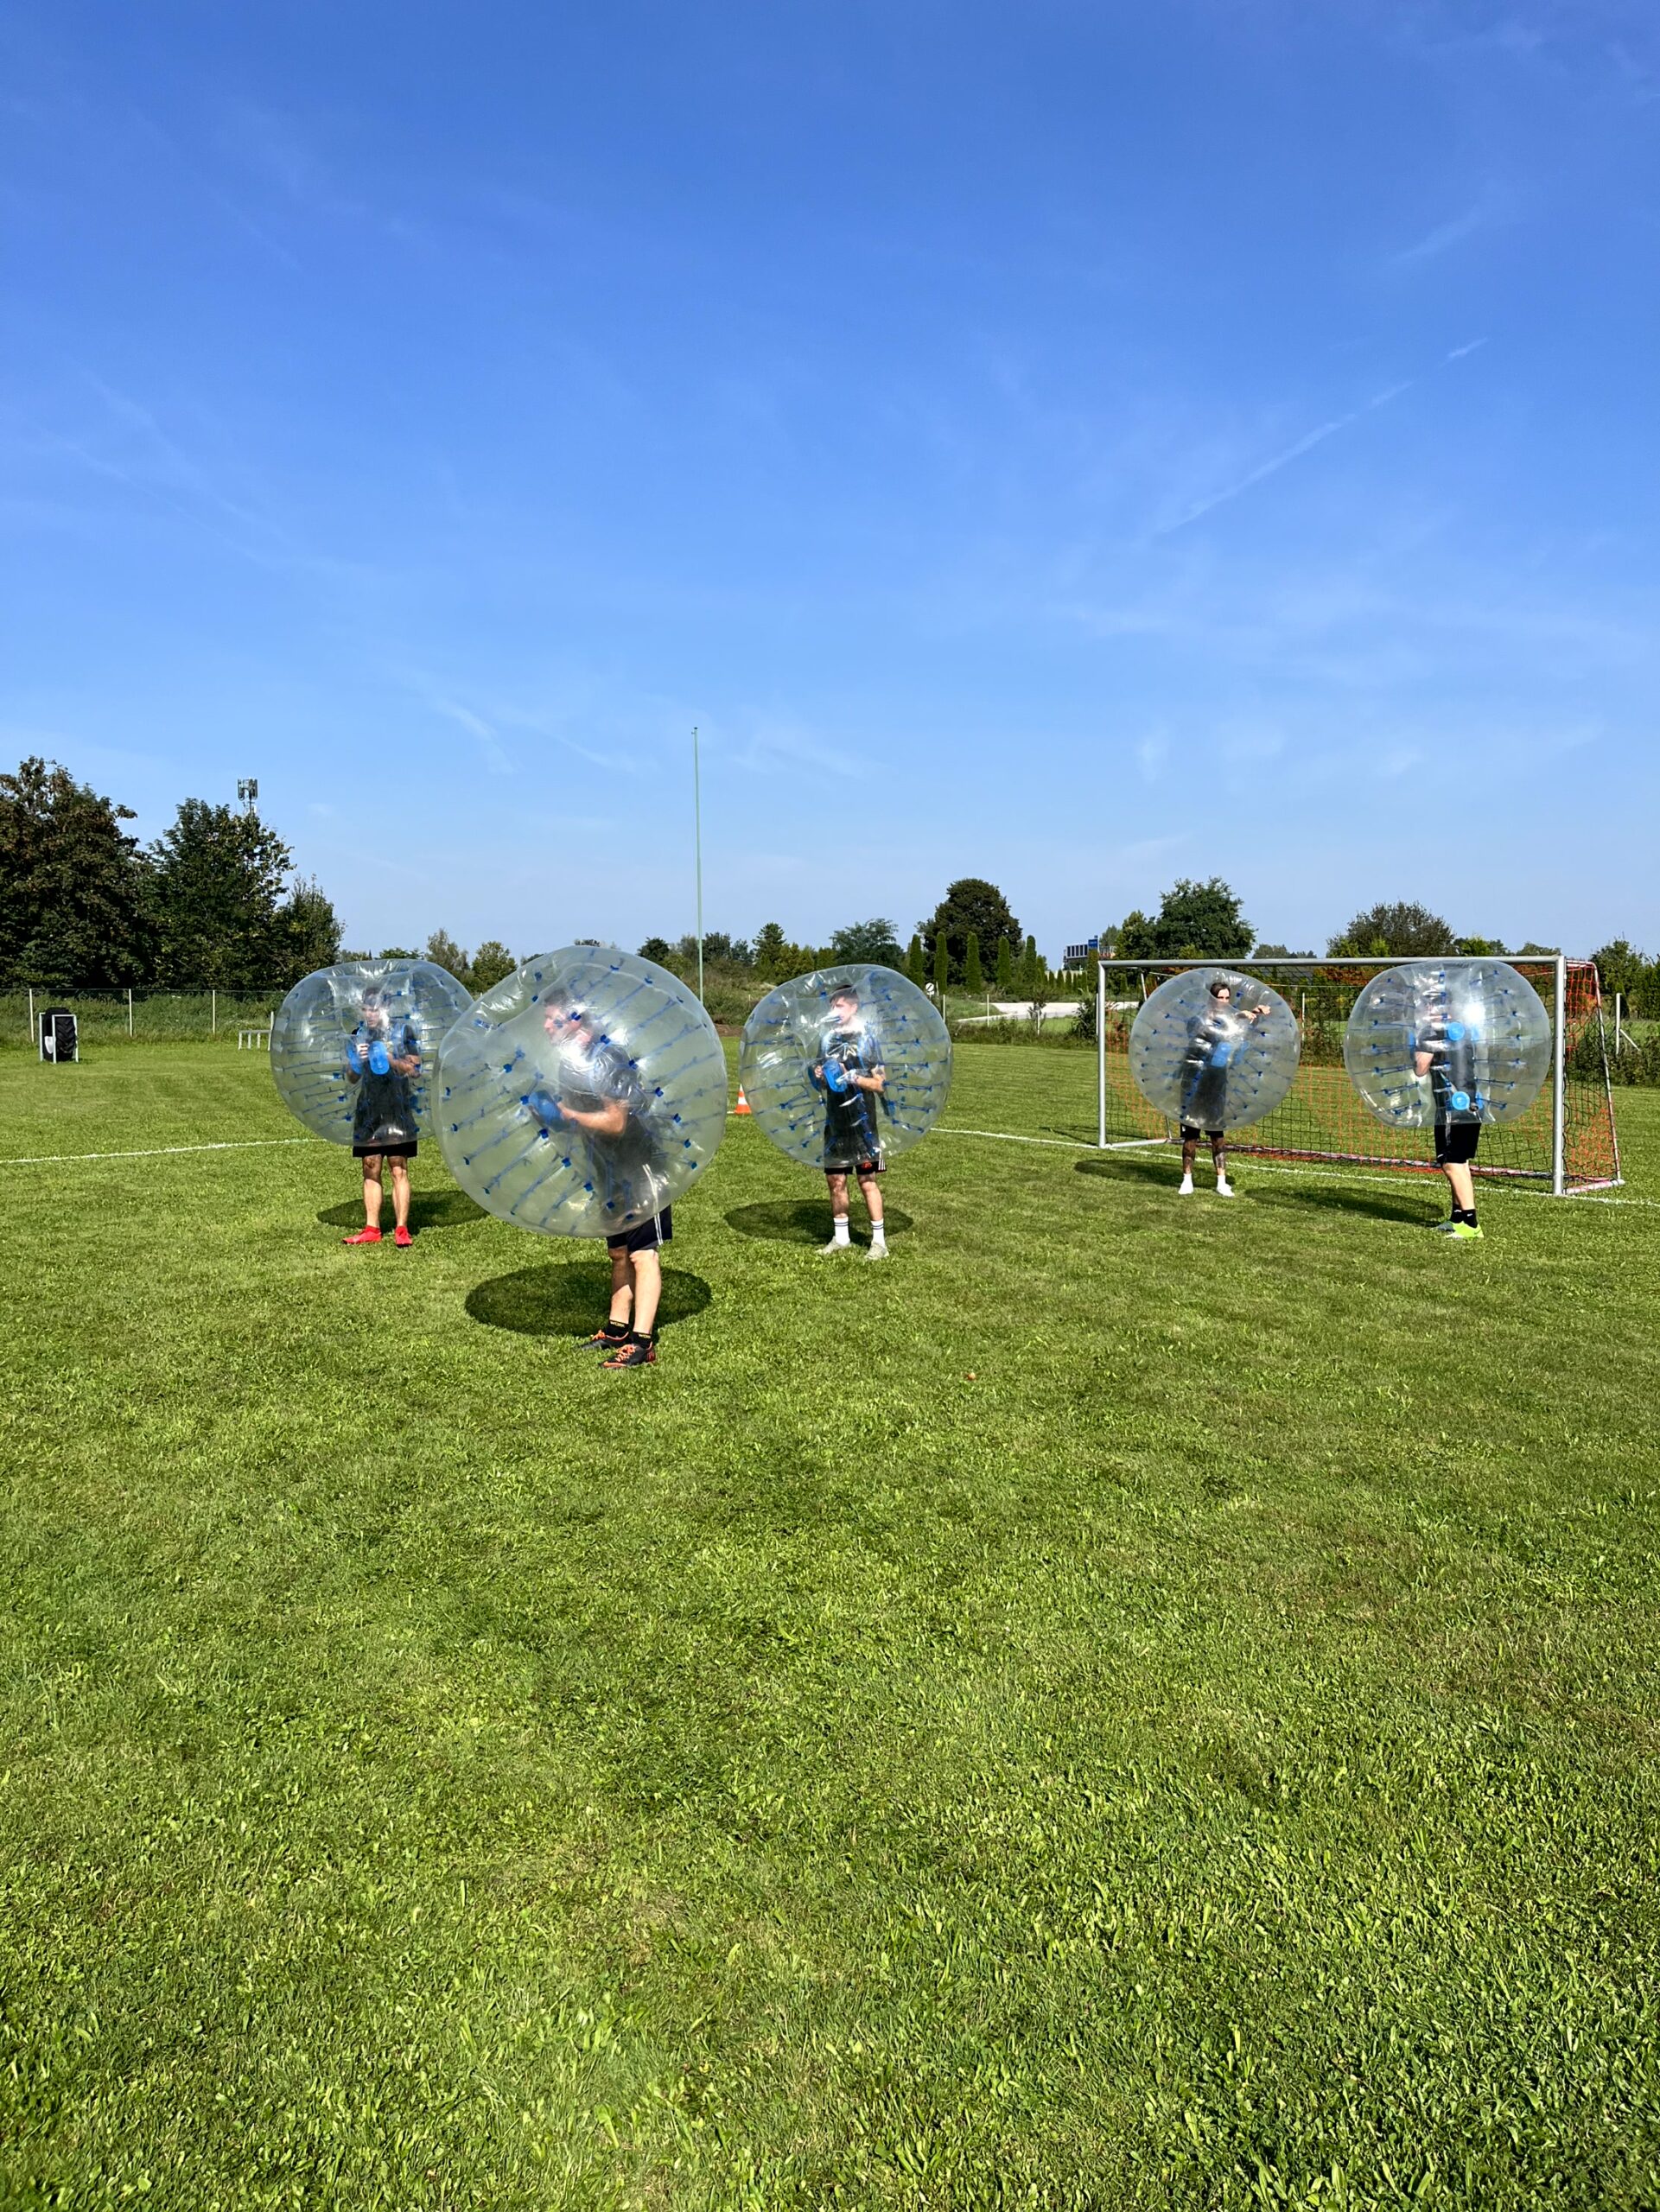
[{"x1": 0, "y1": 0, "x2": 1660, "y2": 953}]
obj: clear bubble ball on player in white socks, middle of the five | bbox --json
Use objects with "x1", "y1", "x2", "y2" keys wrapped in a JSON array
[{"x1": 739, "y1": 960, "x2": 951, "y2": 1170}]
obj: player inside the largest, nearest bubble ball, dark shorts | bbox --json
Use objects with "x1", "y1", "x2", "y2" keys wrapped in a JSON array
[{"x1": 527, "y1": 1007, "x2": 675, "y2": 1367}]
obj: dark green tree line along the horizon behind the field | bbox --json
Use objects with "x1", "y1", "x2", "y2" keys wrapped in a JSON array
[{"x1": 0, "y1": 757, "x2": 1660, "y2": 1002}]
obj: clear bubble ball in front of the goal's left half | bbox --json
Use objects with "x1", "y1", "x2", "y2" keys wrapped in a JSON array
[{"x1": 1129, "y1": 967, "x2": 1301, "y2": 1130}]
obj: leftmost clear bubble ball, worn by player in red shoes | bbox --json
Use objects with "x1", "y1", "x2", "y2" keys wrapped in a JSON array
[{"x1": 270, "y1": 960, "x2": 472, "y2": 1146}]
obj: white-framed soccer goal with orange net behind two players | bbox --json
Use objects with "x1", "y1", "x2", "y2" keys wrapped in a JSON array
[{"x1": 1096, "y1": 953, "x2": 1620, "y2": 1197}]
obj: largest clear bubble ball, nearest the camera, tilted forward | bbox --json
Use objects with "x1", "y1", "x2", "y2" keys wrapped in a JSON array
[{"x1": 436, "y1": 944, "x2": 726, "y2": 1236}]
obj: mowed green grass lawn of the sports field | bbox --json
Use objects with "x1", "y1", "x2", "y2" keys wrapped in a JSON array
[{"x1": 0, "y1": 1044, "x2": 1660, "y2": 2212}]
